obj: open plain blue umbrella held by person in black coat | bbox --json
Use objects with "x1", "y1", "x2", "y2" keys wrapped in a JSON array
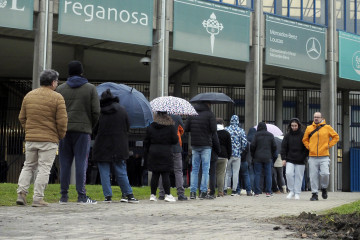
[{"x1": 96, "y1": 82, "x2": 153, "y2": 128}]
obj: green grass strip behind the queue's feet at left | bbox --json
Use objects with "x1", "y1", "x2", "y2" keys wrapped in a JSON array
[{"x1": 0, "y1": 183, "x2": 189, "y2": 206}]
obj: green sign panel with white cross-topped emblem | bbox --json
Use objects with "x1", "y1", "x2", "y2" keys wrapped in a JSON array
[{"x1": 173, "y1": 0, "x2": 250, "y2": 61}]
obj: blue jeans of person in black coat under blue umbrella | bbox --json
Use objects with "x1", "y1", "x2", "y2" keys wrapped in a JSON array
[{"x1": 98, "y1": 160, "x2": 132, "y2": 197}]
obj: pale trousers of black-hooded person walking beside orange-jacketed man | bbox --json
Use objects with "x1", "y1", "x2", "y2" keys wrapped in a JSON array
[{"x1": 286, "y1": 162, "x2": 305, "y2": 194}]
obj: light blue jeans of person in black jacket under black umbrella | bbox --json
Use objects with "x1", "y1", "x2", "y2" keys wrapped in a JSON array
[{"x1": 190, "y1": 146, "x2": 211, "y2": 193}]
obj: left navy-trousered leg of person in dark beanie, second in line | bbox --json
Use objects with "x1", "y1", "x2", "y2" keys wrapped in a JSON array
[{"x1": 59, "y1": 132, "x2": 74, "y2": 201}]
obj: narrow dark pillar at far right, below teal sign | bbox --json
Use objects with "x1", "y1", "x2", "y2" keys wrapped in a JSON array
[{"x1": 341, "y1": 90, "x2": 350, "y2": 192}]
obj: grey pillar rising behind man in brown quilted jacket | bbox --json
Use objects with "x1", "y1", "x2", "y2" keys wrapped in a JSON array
[{"x1": 32, "y1": 0, "x2": 54, "y2": 89}]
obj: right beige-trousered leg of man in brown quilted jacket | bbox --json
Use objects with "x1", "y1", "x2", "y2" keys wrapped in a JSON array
[{"x1": 33, "y1": 142, "x2": 58, "y2": 202}]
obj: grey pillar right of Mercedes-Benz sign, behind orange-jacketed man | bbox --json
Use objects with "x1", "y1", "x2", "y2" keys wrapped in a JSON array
[{"x1": 320, "y1": 1, "x2": 337, "y2": 191}]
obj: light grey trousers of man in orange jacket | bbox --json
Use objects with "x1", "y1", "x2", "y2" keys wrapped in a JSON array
[{"x1": 309, "y1": 157, "x2": 330, "y2": 193}]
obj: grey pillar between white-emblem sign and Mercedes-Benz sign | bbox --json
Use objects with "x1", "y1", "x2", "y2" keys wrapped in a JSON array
[{"x1": 245, "y1": 1, "x2": 264, "y2": 132}]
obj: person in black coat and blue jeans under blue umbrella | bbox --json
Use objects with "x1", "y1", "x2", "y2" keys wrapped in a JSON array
[{"x1": 92, "y1": 89, "x2": 139, "y2": 203}]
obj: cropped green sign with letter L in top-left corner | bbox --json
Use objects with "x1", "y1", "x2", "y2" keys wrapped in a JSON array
[{"x1": 0, "y1": 0, "x2": 34, "y2": 30}]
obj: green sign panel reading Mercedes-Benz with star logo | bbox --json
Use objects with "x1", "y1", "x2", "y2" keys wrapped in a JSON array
[{"x1": 265, "y1": 15, "x2": 326, "y2": 74}]
